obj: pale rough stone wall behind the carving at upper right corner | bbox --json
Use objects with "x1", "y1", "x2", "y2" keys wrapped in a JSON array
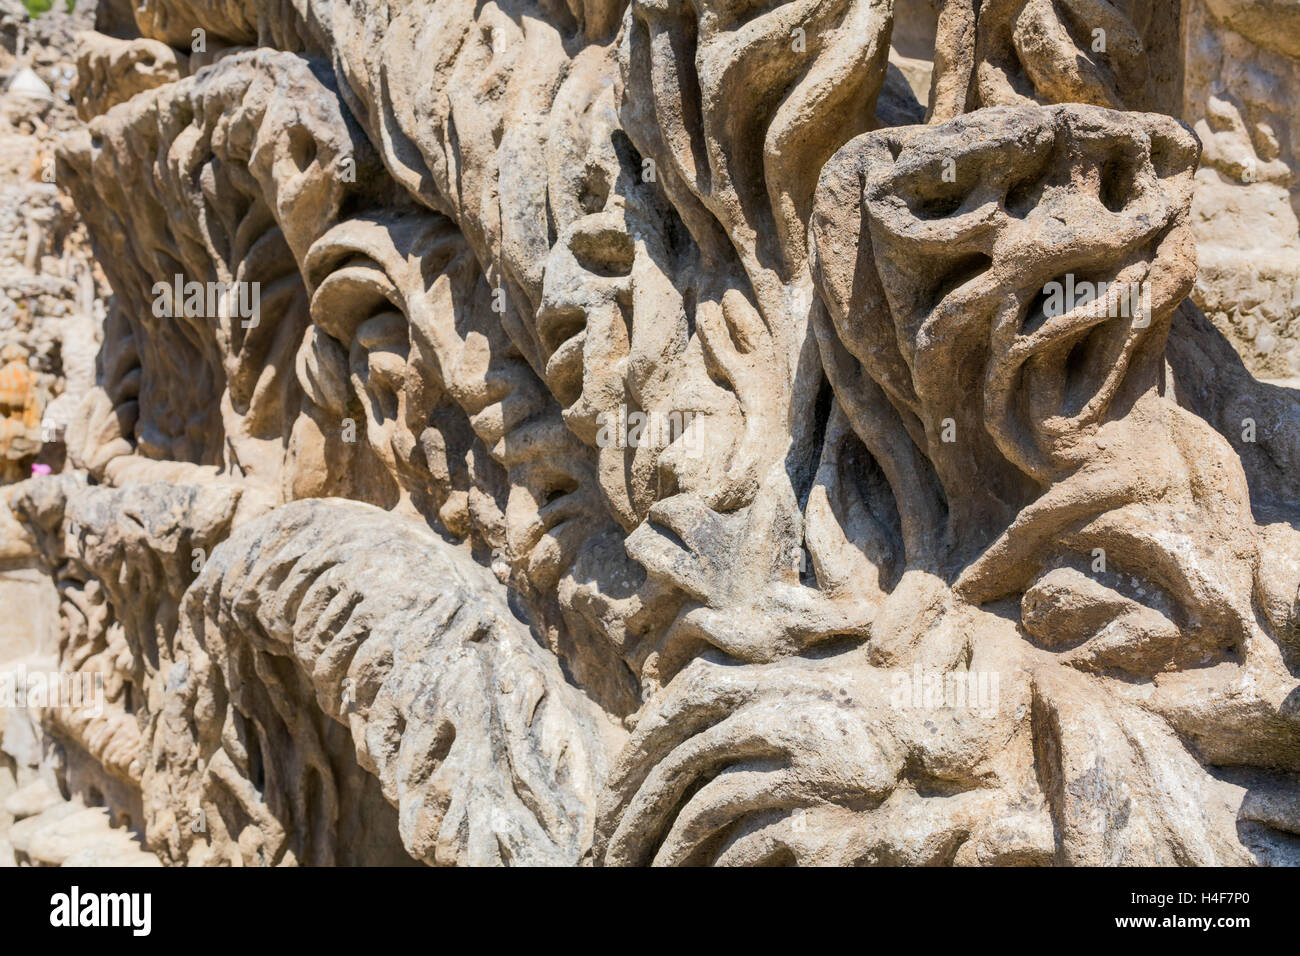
[{"x1": 1183, "y1": 0, "x2": 1300, "y2": 378}]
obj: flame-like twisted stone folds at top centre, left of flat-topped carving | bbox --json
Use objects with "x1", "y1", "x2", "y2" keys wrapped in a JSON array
[{"x1": 624, "y1": 0, "x2": 893, "y2": 280}]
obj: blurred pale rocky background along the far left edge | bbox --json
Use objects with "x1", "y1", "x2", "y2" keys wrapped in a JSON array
[{"x1": 0, "y1": 0, "x2": 139, "y2": 866}]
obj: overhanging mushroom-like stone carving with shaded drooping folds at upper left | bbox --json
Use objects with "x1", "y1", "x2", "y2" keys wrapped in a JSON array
[{"x1": 60, "y1": 51, "x2": 379, "y2": 484}]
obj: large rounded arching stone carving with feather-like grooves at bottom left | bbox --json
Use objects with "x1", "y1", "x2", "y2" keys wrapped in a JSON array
[{"x1": 155, "y1": 499, "x2": 619, "y2": 864}]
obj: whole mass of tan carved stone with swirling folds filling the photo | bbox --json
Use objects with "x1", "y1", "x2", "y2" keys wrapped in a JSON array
[{"x1": 0, "y1": 0, "x2": 1300, "y2": 866}]
